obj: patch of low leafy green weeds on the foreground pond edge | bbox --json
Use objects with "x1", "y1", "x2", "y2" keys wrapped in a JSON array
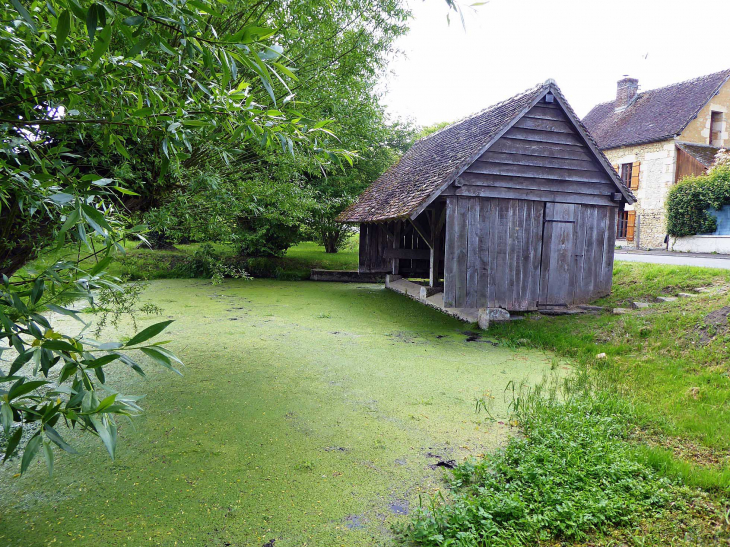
[{"x1": 401, "y1": 384, "x2": 670, "y2": 547}]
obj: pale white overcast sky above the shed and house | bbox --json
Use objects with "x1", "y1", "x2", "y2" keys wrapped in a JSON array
[{"x1": 381, "y1": 0, "x2": 730, "y2": 125}]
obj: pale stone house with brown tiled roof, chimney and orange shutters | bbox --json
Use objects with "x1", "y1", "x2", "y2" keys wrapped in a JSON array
[{"x1": 583, "y1": 70, "x2": 730, "y2": 249}]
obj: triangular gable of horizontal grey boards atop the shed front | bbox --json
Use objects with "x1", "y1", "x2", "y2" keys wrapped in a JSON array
[{"x1": 444, "y1": 100, "x2": 620, "y2": 206}]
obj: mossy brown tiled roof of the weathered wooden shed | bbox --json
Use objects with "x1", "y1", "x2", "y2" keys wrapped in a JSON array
[{"x1": 337, "y1": 80, "x2": 634, "y2": 222}]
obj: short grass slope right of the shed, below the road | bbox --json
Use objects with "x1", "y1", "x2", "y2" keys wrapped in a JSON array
[{"x1": 493, "y1": 262, "x2": 730, "y2": 454}]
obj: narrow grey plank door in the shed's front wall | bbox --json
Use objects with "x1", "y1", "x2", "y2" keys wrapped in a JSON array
[{"x1": 538, "y1": 203, "x2": 580, "y2": 306}]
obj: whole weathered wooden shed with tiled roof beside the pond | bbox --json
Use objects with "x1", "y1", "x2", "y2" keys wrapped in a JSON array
[{"x1": 339, "y1": 80, "x2": 635, "y2": 311}]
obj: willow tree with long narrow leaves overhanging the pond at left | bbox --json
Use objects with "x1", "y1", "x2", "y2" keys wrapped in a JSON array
[{"x1": 0, "y1": 0, "x2": 347, "y2": 472}]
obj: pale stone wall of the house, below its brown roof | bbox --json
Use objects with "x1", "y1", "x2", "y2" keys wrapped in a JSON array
[{"x1": 604, "y1": 140, "x2": 677, "y2": 249}]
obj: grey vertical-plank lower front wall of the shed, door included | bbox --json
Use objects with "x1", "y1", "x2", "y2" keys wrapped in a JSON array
[{"x1": 444, "y1": 196, "x2": 616, "y2": 311}]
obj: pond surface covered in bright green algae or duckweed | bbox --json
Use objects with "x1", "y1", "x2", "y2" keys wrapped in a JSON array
[{"x1": 0, "y1": 280, "x2": 553, "y2": 547}]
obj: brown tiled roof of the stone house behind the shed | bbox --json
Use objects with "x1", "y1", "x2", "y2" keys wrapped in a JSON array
[{"x1": 583, "y1": 70, "x2": 730, "y2": 150}]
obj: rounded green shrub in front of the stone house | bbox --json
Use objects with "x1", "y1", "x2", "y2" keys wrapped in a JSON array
[{"x1": 667, "y1": 163, "x2": 730, "y2": 237}]
